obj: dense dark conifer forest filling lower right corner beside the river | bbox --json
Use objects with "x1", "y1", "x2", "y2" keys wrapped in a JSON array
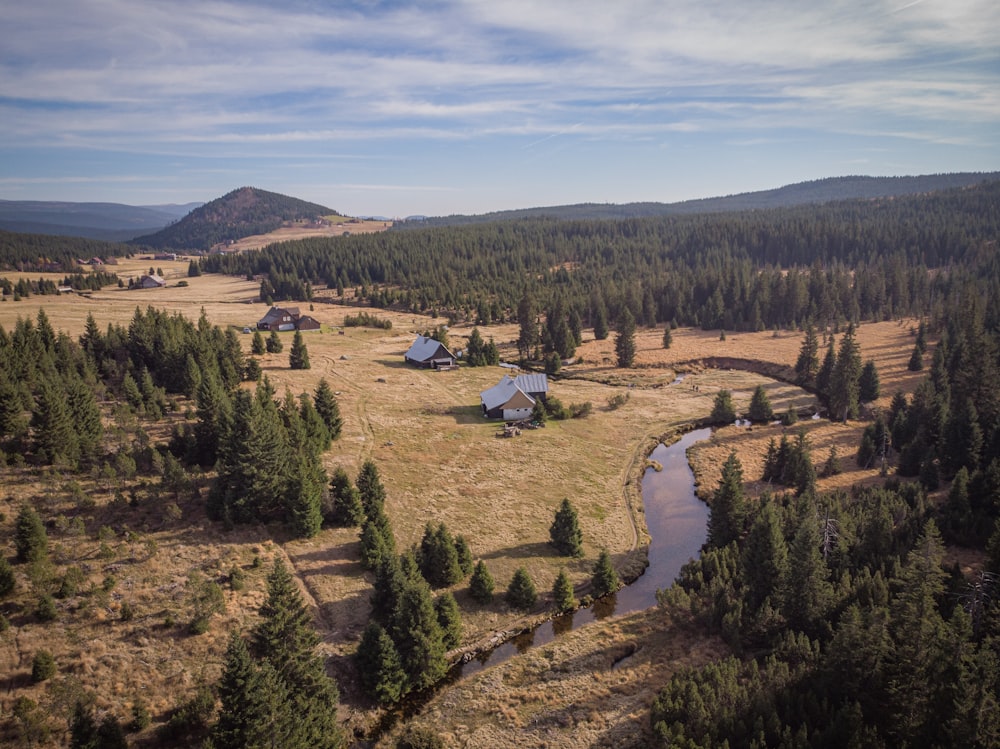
[{"x1": 651, "y1": 442, "x2": 1000, "y2": 747}]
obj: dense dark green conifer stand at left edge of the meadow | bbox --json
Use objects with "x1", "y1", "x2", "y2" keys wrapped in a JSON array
[{"x1": 0, "y1": 308, "x2": 343, "y2": 536}]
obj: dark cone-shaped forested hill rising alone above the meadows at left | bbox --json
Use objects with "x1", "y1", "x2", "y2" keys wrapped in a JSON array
[{"x1": 132, "y1": 187, "x2": 339, "y2": 250}]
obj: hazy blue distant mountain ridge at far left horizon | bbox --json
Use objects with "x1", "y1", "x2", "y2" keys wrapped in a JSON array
[{"x1": 0, "y1": 200, "x2": 201, "y2": 241}]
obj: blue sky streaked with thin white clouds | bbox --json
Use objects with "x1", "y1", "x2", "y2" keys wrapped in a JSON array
[{"x1": 0, "y1": 0, "x2": 1000, "y2": 217}]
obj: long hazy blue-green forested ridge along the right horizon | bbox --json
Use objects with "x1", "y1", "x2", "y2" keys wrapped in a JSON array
[{"x1": 393, "y1": 172, "x2": 1000, "y2": 226}]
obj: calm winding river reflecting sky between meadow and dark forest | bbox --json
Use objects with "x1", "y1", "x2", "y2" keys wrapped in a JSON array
[{"x1": 453, "y1": 428, "x2": 712, "y2": 678}]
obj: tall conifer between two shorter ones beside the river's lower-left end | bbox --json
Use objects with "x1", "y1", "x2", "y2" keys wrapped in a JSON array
[{"x1": 392, "y1": 578, "x2": 448, "y2": 690}]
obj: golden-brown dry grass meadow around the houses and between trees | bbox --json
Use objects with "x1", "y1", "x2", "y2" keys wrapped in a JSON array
[{"x1": 0, "y1": 258, "x2": 918, "y2": 747}]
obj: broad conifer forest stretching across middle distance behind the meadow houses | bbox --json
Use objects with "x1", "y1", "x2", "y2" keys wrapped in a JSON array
[{"x1": 201, "y1": 183, "x2": 1000, "y2": 338}]
